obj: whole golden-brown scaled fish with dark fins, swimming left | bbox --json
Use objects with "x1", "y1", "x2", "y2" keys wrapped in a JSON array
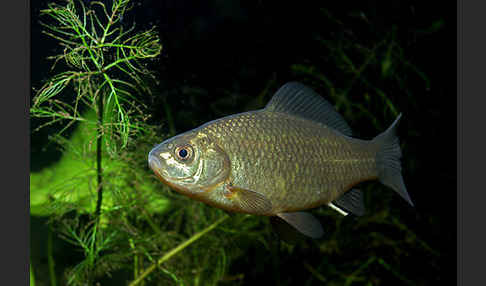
[{"x1": 148, "y1": 82, "x2": 413, "y2": 238}]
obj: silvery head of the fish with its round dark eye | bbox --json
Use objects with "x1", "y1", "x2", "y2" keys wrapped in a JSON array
[{"x1": 148, "y1": 131, "x2": 230, "y2": 199}]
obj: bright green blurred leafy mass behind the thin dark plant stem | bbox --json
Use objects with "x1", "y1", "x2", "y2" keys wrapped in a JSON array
[{"x1": 30, "y1": 111, "x2": 168, "y2": 218}]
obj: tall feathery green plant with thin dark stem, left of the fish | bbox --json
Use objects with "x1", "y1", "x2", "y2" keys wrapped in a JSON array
[{"x1": 30, "y1": 0, "x2": 162, "y2": 283}]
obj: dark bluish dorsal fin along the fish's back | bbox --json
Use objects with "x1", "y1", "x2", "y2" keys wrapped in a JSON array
[{"x1": 265, "y1": 82, "x2": 352, "y2": 136}]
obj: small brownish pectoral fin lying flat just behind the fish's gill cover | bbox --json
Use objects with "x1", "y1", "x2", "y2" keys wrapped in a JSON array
[{"x1": 225, "y1": 185, "x2": 272, "y2": 214}]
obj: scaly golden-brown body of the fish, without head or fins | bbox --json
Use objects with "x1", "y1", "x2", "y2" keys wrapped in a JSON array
[{"x1": 198, "y1": 111, "x2": 377, "y2": 212}]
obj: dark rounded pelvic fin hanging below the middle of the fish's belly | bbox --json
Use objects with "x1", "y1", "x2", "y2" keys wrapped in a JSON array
[{"x1": 277, "y1": 212, "x2": 324, "y2": 238}]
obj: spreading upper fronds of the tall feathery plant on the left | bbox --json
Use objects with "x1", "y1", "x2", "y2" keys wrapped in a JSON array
[{"x1": 30, "y1": 0, "x2": 162, "y2": 155}]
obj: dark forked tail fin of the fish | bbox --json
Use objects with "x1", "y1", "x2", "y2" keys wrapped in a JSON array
[{"x1": 373, "y1": 114, "x2": 413, "y2": 206}]
